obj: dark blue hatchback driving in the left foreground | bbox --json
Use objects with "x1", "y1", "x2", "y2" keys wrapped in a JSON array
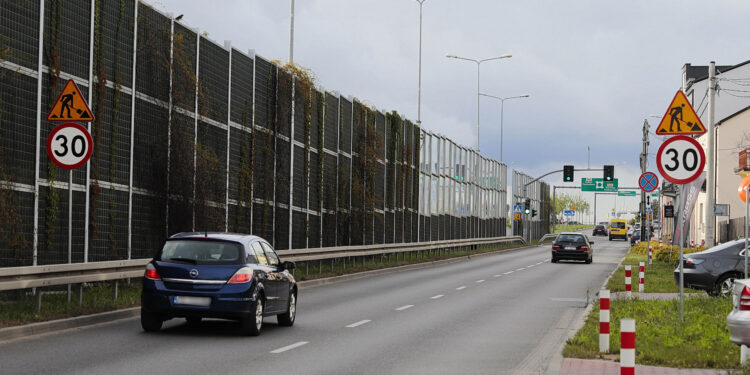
[{"x1": 141, "y1": 232, "x2": 297, "y2": 336}]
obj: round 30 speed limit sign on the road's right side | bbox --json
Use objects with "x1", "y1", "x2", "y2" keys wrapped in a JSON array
[{"x1": 656, "y1": 135, "x2": 706, "y2": 184}]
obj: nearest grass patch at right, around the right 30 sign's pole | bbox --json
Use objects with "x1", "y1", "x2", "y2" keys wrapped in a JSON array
[{"x1": 563, "y1": 296, "x2": 740, "y2": 369}]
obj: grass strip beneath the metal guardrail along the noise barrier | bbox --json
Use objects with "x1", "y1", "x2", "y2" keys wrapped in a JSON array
[{"x1": 0, "y1": 241, "x2": 538, "y2": 328}]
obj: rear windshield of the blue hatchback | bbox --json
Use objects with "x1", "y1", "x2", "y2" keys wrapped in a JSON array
[{"x1": 158, "y1": 239, "x2": 242, "y2": 264}]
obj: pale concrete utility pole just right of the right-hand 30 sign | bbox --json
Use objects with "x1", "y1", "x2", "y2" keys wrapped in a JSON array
[{"x1": 704, "y1": 61, "x2": 716, "y2": 247}]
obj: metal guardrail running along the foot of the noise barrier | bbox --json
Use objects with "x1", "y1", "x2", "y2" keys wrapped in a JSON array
[{"x1": 0, "y1": 236, "x2": 526, "y2": 291}]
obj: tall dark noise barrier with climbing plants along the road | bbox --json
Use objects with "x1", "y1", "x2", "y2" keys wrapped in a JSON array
[{"x1": 0, "y1": 0, "x2": 544, "y2": 267}]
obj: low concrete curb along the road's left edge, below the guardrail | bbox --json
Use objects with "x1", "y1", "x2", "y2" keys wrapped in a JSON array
[{"x1": 0, "y1": 241, "x2": 539, "y2": 344}]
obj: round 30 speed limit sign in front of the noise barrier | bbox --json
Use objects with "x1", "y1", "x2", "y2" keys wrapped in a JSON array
[{"x1": 47, "y1": 122, "x2": 94, "y2": 169}]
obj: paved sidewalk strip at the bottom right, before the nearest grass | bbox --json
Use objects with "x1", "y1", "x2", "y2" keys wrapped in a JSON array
[{"x1": 560, "y1": 358, "x2": 729, "y2": 375}]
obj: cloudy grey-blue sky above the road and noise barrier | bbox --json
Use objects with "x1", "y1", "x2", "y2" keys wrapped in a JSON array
[{"x1": 150, "y1": 0, "x2": 750, "y2": 221}]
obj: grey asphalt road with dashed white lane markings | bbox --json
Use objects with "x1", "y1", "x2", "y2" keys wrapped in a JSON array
[{"x1": 0, "y1": 237, "x2": 628, "y2": 375}]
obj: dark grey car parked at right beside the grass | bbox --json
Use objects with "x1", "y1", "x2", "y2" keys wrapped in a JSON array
[{"x1": 674, "y1": 239, "x2": 745, "y2": 296}]
